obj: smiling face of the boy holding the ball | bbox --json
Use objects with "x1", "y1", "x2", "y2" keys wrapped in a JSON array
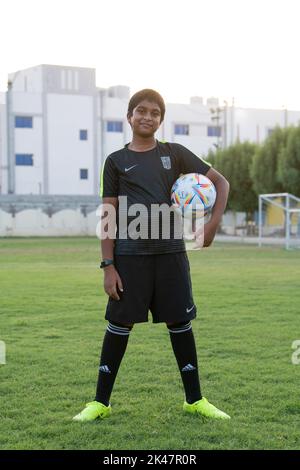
[{"x1": 128, "y1": 100, "x2": 161, "y2": 137}]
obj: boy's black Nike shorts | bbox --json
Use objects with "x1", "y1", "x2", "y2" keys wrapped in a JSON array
[{"x1": 105, "y1": 252, "x2": 196, "y2": 324}]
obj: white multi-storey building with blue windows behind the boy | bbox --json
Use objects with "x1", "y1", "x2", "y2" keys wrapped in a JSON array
[{"x1": 0, "y1": 65, "x2": 300, "y2": 195}]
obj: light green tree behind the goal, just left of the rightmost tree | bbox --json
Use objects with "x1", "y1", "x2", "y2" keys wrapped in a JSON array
[{"x1": 251, "y1": 127, "x2": 292, "y2": 194}]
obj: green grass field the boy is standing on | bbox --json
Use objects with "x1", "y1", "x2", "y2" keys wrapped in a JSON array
[{"x1": 0, "y1": 238, "x2": 300, "y2": 450}]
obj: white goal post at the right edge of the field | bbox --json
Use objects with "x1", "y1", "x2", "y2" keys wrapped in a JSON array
[{"x1": 258, "y1": 193, "x2": 300, "y2": 250}]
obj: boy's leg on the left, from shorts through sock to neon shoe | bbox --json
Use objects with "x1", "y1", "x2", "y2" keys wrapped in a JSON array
[{"x1": 73, "y1": 255, "x2": 154, "y2": 421}]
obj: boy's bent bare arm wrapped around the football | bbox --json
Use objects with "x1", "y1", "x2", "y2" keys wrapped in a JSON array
[{"x1": 199, "y1": 168, "x2": 229, "y2": 247}]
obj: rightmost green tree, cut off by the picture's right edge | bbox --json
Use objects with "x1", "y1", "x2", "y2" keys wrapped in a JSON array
[{"x1": 277, "y1": 127, "x2": 300, "y2": 196}]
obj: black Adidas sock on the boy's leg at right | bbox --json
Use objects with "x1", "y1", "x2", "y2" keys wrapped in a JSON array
[{"x1": 168, "y1": 322, "x2": 202, "y2": 403}]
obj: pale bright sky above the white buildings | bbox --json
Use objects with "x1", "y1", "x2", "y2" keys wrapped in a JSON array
[{"x1": 0, "y1": 0, "x2": 300, "y2": 110}]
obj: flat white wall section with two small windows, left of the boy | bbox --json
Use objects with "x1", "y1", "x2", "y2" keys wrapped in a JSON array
[{"x1": 47, "y1": 94, "x2": 95, "y2": 194}]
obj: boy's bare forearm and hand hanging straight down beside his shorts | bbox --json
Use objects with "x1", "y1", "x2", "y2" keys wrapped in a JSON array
[{"x1": 101, "y1": 197, "x2": 123, "y2": 300}]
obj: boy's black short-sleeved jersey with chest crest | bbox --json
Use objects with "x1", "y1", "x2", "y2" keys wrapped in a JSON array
[{"x1": 100, "y1": 142, "x2": 210, "y2": 255}]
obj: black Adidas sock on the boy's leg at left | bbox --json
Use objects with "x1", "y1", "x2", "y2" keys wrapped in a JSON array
[{"x1": 95, "y1": 322, "x2": 132, "y2": 406}]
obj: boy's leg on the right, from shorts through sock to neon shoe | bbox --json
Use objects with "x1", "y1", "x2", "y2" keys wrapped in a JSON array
[{"x1": 151, "y1": 252, "x2": 230, "y2": 419}]
